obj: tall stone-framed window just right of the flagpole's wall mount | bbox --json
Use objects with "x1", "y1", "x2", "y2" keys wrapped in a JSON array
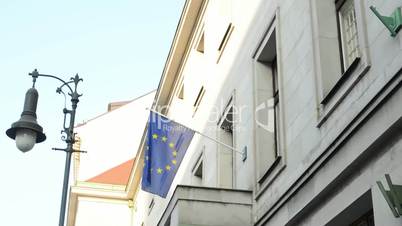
[{"x1": 254, "y1": 22, "x2": 281, "y2": 185}]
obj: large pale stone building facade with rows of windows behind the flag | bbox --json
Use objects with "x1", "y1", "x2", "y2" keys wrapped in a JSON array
[{"x1": 132, "y1": 0, "x2": 402, "y2": 226}]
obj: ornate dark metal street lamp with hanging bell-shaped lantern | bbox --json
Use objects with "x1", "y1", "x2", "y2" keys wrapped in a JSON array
[{"x1": 6, "y1": 69, "x2": 83, "y2": 226}]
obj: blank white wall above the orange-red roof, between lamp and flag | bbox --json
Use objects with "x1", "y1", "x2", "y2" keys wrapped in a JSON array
[{"x1": 76, "y1": 92, "x2": 155, "y2": 181}]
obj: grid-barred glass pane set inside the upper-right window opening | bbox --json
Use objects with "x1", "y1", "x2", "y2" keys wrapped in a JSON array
[{"x1": 336, "y1": 0, "x2": 360, "y2": 71}]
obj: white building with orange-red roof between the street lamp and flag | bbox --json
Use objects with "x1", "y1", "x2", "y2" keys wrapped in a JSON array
[{"x1": 67, "y1": 92, "x2": 155, "y2": 226}]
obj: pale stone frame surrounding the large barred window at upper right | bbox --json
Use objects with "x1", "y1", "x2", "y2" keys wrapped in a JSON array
[{"x1": 310, "y1": 0, "x2": 371, "y2": 128}]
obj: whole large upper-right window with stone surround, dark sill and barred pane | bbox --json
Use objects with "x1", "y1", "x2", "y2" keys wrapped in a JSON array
[{"x1": 311, "y1": 0, "x2": 370, "y2": 119}]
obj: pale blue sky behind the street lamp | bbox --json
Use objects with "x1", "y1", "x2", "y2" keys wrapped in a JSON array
[{"x1": 0, "y1": 0, "x2": 184, "y2": 226}]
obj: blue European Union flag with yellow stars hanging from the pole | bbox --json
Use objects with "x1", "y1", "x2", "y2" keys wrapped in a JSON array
[{"x1": 142, "y1": 111, "x2": 194, "y2": 198}]
